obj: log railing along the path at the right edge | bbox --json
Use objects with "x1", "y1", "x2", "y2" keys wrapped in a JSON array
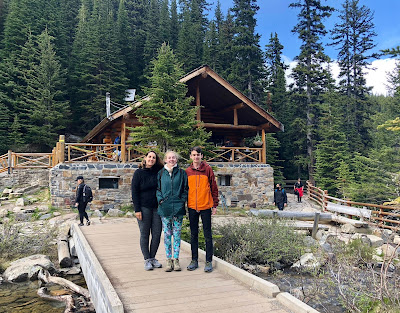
[{"x1": 307, "y1": 181, "x2": 400, "y2": 232}]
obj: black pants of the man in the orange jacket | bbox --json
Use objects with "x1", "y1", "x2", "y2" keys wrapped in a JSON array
[{"x1": 189, "y1": 209, "x2": 213, "y2": 262}]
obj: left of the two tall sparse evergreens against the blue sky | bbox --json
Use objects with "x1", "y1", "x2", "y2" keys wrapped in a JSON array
[{"x1": 289, "y1": 0, "x2": 333, "y2": 182}]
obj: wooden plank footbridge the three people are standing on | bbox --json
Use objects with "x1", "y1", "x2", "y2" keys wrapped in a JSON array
[{"x1": 71, "y1": 219, "x2": 317, "y2": 313}]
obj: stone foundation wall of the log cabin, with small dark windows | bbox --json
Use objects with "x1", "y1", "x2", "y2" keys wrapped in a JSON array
[{"x1": 50, "y1": 162, "x2": 274, "y2": 209}]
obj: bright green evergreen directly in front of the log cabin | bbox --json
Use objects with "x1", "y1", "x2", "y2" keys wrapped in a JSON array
[{"x1": 131, "y1": 43, "x2": 210, "y2": 157}]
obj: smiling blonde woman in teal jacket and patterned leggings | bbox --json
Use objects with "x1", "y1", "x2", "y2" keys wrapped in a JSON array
[{"x1": 157, "y1": 151, "x2": 188, "y2": 272}]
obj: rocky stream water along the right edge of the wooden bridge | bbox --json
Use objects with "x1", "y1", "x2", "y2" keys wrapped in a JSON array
[{"x1": 258, "y1": 269, "x2": 347, "y2": 313}]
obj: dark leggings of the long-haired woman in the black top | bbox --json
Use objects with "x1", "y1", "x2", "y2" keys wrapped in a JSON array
[{"x1": 138, "y1": 207, "x2": 162, "y2": 260}]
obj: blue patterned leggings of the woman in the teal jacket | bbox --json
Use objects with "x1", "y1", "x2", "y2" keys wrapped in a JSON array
[{"x1": 161, "y1": 216, "x2": 183, "y2": 259}]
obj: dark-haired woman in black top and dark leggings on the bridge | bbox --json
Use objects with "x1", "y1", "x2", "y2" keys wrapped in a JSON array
[{"x1": 131, "y1": 151, "x2": 163, "y2": 271}]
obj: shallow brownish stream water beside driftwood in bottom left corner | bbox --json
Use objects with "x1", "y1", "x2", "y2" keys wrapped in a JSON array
[{"x1": 0, "y1": 275, "x2": 86, "y2": 313}]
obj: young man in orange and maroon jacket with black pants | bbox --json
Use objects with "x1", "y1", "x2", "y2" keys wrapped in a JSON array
[{"x1": 186, "y1": 147, "x2": 218, "y2": 272}]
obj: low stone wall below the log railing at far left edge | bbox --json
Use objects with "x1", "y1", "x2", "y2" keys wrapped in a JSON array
[{"x1": 0, "y1": 168, "x2": 49, "y2": 193}]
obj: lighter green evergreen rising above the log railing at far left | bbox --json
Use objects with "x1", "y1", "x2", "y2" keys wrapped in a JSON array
[{"x1": 22, "y1": 29, "x2": 69, "y2": 151}]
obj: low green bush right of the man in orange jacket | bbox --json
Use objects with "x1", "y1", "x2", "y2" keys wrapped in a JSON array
[{"x1": 215, "y1": 219, "x2": 305, "y2": 268}]
